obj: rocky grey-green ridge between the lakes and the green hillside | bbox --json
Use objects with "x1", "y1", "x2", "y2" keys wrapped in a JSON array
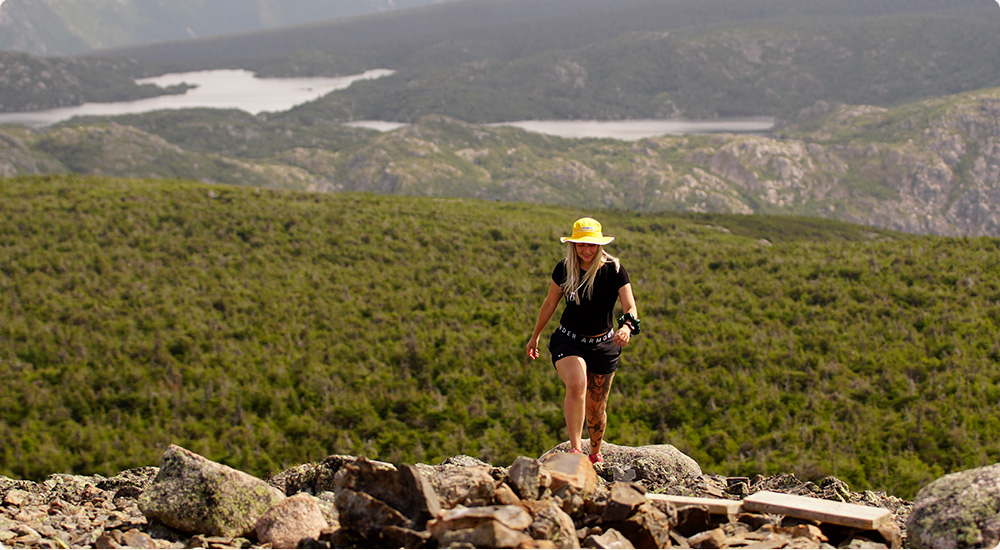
[{"x1": 0, "y1": 89, "x2": 1000, "y2": 236}]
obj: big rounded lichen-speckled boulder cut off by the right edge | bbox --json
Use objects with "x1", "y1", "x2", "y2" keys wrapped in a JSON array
[{"x1": 906, "y1": 464, "x2": 1000, "y2": 548}]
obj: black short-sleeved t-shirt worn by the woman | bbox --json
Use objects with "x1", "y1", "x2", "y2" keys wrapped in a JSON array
[{"x1": 552, "y1": 260, "x2": 630, "y2": 336}]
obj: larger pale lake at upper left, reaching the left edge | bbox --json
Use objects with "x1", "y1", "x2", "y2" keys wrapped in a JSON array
[{"x1": 0, "y1": 69, "x2": 394, "y2": 126}]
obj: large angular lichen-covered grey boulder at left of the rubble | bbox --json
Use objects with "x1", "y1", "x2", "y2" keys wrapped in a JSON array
[{"x1": 139, "y1": 445, "x2": 285, "y2": 537}]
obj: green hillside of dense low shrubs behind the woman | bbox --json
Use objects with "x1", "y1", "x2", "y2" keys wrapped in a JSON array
[{"x1": 0, "y1": 176, "x2": 1000, "y2": 498}]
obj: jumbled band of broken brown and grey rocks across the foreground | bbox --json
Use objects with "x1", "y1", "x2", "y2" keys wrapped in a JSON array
[{"x1": 0, "y1": 444, "x2": 911, "y2": 548}]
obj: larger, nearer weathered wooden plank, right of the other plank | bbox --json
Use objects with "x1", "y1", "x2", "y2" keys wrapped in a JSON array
[{"x1": 743, "y1": 491, "x2": 892, "y2": 530}]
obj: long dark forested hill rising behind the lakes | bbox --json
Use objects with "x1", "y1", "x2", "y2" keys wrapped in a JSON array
[{"x1": 15, "y1": 0, "x2": 1000, "y2": 122}]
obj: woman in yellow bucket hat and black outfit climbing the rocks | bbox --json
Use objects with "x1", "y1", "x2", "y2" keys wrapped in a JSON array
[{"x1": 527, "y1": 218, "x2": 639, "y2": 464}]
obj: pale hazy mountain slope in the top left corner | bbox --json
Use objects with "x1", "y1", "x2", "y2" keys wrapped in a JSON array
[{"x1": 0, "y1": 0, "x2": 453, "y2": 56}]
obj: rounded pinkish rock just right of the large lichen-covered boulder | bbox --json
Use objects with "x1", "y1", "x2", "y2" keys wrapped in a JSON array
[{"x1": 254, "y1": 493, "x2": 329, "y2": 548}]
